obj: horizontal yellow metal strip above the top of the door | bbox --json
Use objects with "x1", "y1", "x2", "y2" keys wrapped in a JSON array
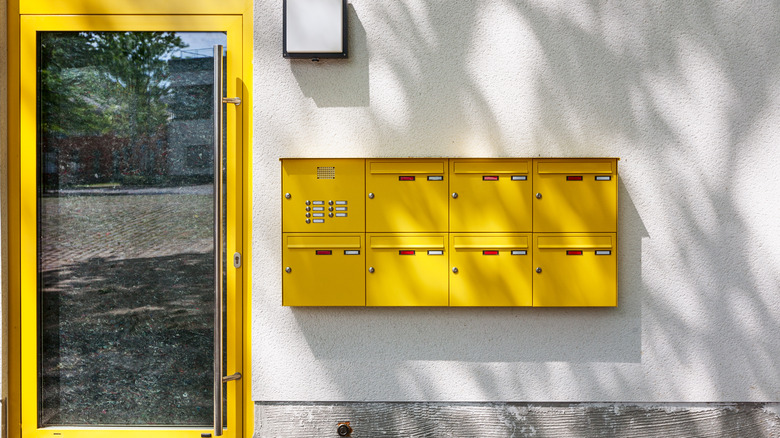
[{"x1": 19, "y1": 0, "x2": 251, "y2": 14}]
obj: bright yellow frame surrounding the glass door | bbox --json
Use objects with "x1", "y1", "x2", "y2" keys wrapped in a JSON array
[{"x1": 6, "y1": 0, "x2": 254, "y2": 438}]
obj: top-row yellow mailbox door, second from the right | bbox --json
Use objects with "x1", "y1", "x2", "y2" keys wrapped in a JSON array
[{"x1": 450, "y1": 159, "x2": 533, "y2": 232}]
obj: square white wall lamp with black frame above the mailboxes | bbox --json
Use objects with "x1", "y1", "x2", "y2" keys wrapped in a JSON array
[{"x1": 282, "y1": 0, "x2": 347, "y2": 61}]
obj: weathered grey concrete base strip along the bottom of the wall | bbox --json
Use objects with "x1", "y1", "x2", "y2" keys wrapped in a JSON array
[{"x1": 255, "y1": 402, "x2": 780, "y2": 438}]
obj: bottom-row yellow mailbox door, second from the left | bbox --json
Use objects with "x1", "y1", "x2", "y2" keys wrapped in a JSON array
[{"x1": 366, "y1": 233, "x2": 449, "y2": 306}]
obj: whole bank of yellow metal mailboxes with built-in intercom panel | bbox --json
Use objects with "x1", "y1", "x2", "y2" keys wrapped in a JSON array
[{"x1": 281, "y1": 158, "x2": 618, "y2": 307}]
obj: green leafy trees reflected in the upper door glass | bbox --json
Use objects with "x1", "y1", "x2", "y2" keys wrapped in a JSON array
[{"x1": 39, "y1": 32, "x2": 185, "y2": 188}]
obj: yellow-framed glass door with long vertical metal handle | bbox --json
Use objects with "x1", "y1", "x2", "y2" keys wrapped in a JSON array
[{"x1": 21, "y1": 16, "x2": 242, "y2": 438}]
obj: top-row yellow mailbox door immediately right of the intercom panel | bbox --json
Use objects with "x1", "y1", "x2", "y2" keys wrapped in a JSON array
[{"x1": 366, "y1": 159, "x2": 448, "y2": 233}]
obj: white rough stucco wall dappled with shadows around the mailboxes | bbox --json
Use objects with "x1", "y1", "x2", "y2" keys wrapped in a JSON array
[{"x1": 252, "y1": 0, "x2": 780, "y2": 402}]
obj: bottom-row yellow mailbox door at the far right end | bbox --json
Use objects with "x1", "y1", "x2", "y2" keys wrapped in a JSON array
[{"x1": 533, "y1": 233, "x2": 617, "y2": 307}]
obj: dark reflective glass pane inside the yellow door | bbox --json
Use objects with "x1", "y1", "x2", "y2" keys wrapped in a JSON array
[{"x1": 38, "y1": 32, "x2": 226, "y2": 427}]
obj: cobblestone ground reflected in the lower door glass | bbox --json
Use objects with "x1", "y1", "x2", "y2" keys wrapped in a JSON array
[{"x1": 40, "y1": 193, "x2": 222, "y2": 425}]
